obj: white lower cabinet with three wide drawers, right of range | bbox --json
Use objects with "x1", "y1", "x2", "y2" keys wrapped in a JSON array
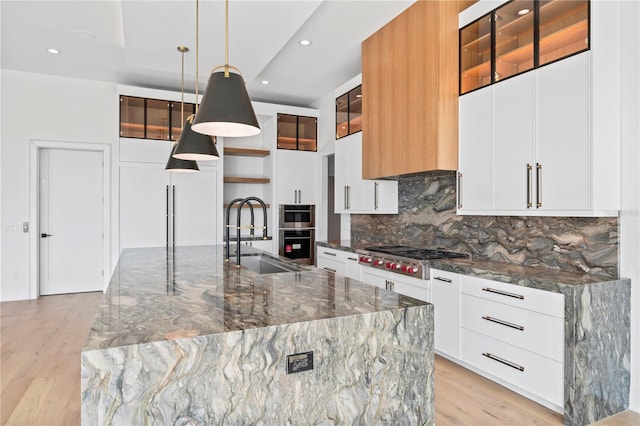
[{"x1": 431, "y1": 269, "x2": 564, "y2": 412}]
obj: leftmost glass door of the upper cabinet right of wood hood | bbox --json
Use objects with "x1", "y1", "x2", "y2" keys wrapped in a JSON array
[{"x1": 460, "y1": 14, "x2": 491, "y2": 94}]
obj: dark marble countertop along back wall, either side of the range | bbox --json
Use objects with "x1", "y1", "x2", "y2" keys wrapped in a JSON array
[{"x1": 317, "y1": 241, "x2": 618, "y2": 293}]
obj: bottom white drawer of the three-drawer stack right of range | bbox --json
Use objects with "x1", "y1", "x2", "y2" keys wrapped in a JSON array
[{"x1": 460, "y1": 327, "x2": 564, "y2": 407}]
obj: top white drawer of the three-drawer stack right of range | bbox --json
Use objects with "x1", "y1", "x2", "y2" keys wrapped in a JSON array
[{"x1": 460, "y1": 276, "x2": 564, "y2": 318}]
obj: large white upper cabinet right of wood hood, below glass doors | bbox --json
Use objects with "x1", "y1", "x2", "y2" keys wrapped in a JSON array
[{"x1": 457, "y1": 2, "x2": 620, "y2": 216}]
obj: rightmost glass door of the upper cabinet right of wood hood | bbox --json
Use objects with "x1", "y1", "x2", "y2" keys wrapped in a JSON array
[{"x1": 540, "y1": 0, "x2": 589, "y2": 65}]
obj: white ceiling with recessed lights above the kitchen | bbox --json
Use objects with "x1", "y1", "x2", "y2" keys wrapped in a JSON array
[{"x1": 0, "y1": 0, "x2": 415, "y2": 106}]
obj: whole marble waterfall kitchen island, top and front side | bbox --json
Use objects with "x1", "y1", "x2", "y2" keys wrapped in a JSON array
[{"x1": 81, "y1": 246, "x2": 435, "y2": 425}]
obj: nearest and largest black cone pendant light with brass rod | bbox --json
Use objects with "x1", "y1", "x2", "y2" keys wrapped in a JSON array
[{"x1": 193, "y1": 0, "x2": 260, "y2": 137}]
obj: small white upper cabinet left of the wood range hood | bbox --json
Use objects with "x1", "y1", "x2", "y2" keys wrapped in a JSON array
[{"x1": 334, "y1": 132, "x2": 398, "y2": 214}]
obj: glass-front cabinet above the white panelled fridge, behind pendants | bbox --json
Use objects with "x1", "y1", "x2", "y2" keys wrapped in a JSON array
[{"x1": 120, "y1": 96, "x2": 195, "y2": 141}]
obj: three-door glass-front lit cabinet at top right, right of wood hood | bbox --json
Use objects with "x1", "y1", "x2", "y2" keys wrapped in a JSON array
[{"x1": 459, "y1": 0, "x2": 589, "y2": 94}]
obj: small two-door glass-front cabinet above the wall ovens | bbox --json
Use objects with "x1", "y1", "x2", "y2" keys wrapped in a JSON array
[{"x1": 278, "y1": 114, "x2": 318, "y2": 151}]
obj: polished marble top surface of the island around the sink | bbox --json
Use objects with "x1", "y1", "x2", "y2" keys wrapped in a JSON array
[{"x1": 83, "y1": 245, "x2": 426, "y2": 351}]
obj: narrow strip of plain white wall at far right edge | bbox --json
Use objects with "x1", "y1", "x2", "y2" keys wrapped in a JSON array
[{"x1": 620, "y1": 1, "x2": 640, "y2": 411}]
